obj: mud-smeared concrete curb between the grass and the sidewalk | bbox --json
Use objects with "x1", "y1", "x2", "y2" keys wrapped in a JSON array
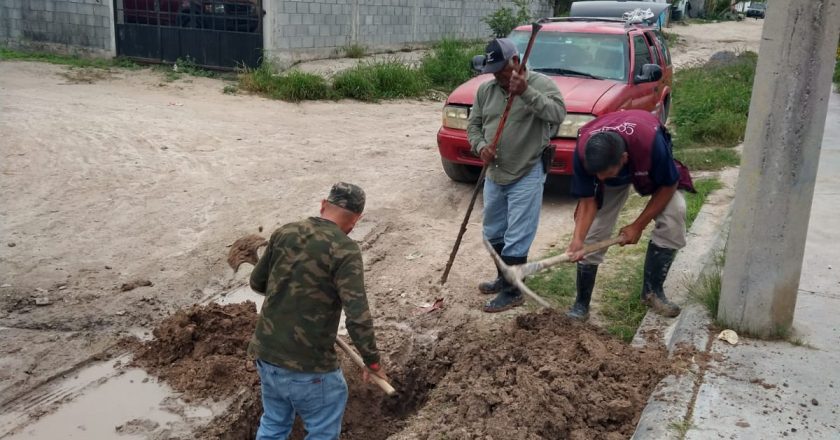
[{"x1": 632, "y1": 169, "x2": 738, "y2": 440}]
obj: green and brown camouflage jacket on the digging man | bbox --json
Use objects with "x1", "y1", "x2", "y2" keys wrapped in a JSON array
[{"x1": 248, "y1": 217, "x2": 379, "y2": 373}]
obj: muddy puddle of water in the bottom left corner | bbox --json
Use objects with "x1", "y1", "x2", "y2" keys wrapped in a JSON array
[{"x1": 0, "y1": 355, "x2": 214, "y2": 440}]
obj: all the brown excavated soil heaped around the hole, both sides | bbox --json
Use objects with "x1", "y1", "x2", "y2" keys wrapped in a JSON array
[{"x1": 135, "y1": 302, "x2": 671, "y2": 440}]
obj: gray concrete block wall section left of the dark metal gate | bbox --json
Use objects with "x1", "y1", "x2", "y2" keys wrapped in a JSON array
[{"x1": 0, "y1": 0, "x2": 116, "y2": 55}]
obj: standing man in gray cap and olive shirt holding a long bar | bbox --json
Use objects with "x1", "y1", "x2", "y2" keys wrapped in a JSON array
[{"x1": 467, "y1": 38, "x2": 566, "y2": 313}]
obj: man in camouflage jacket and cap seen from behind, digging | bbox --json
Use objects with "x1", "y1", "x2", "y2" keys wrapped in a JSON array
[{"x1": 248, "y1": 182, "x2": 385, "y2": 440}]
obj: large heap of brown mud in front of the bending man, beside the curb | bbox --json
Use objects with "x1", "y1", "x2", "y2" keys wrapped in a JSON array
[{"x1": 412, "y1": 311, "x2": 670, "y2": 439}]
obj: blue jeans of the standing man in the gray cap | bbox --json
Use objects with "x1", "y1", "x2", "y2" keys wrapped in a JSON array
[{"x1": 484, "y1": 162, "x2": 545, "y2": 257}]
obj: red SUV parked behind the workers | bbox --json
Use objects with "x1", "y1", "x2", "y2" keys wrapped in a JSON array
[{"x1": 437, "y1": 18, "x2": 673, "y2": 182}]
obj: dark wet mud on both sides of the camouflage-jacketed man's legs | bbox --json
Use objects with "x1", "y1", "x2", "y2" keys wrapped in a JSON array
[{"x1": 133, "y1": 302, "x2": 440, "y2": 440}]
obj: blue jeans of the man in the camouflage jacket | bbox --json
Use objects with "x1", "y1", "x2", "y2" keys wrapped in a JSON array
[{"x1": 257, "y1": 359, "x2": 347, "y2": 440}]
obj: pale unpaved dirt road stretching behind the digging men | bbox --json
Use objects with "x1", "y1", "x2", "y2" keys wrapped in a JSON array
[{"x1": 0, "y1": 18, "x2": 758, "y2": 440}]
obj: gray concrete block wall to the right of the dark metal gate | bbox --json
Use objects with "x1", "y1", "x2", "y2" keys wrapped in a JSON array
[{"x1": 263, "y1": 0, "x2": 552, "y2": 64}]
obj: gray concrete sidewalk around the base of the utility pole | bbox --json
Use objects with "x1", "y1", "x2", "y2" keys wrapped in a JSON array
[{"x1": 685, "y1": 93, "x2": 840, "y2": 440}]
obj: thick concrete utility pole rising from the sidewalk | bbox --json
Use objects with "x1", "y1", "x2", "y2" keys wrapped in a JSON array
[{"x1": 718, "y1": 0, "x2": 840, "y2": 337}]
